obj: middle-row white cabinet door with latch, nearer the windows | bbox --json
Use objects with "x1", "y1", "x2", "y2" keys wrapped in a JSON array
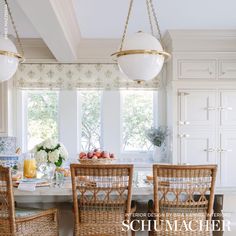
[{"x1": 178, "y1": 90, "x2": 217, "y2": 127}]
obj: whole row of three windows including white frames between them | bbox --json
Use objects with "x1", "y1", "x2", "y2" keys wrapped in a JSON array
[{"x1": 20, "y1": 90, "x2": 157, "y2": 160}]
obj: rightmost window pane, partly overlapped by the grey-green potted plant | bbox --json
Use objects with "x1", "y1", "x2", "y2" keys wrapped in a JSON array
[{"x1": 122, "y1": 91, "x2": 154, "y2": 151}]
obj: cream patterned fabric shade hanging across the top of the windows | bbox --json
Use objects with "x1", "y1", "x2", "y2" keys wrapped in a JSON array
[{"x1": 14, "y1": 64, "x2": 160, "y2": 90}]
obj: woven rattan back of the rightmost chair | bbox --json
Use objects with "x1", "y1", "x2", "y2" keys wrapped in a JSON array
[{"x1": 153, "y1": 165, "x2": 217, "y2": 232}]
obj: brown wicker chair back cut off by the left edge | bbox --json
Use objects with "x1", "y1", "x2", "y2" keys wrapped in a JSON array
[{"x1": 0, "y1": 166, "x2": 15, "y2": 235}]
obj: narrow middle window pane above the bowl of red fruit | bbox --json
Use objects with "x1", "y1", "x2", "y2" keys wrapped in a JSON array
[{"x1": 80, "y1": 91, "x2": 102, "y2": 152}]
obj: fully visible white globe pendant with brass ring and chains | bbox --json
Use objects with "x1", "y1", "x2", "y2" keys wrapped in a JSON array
[{"x1": 112, "y1": 0, "x2": 170, "y2": 82}]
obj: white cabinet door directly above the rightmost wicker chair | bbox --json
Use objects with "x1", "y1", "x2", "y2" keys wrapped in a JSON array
[{"x1": 179, "y1": 129, "x2": 217, "y2": 165}]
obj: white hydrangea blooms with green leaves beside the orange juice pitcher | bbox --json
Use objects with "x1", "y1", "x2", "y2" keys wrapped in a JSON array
[{"x1": 32, "y1": 139, "x2": 68, "y2": 167}]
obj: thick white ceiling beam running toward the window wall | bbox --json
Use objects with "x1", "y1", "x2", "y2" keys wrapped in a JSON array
[{"x1": 17, "y1": 0, "x2": 81, "y2": 63}]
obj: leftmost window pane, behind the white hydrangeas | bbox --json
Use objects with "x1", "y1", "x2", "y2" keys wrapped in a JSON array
[{"x1": 26, "y1": 91, "x2": 58, "y2": 150}]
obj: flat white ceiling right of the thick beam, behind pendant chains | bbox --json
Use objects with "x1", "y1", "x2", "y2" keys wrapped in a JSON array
[{"x1": 74, "y1": 0, "x2": 236, "y2": 38}]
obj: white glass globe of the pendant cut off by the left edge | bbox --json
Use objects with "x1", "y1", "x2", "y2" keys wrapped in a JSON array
[{"x1": 0, "y1": 37, "x2": 19, "y2": 82}]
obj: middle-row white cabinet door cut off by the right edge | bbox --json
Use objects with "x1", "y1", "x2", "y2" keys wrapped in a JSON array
[{"x1": 219, "y1": 90, "x2": 236, "y2": 128}]
